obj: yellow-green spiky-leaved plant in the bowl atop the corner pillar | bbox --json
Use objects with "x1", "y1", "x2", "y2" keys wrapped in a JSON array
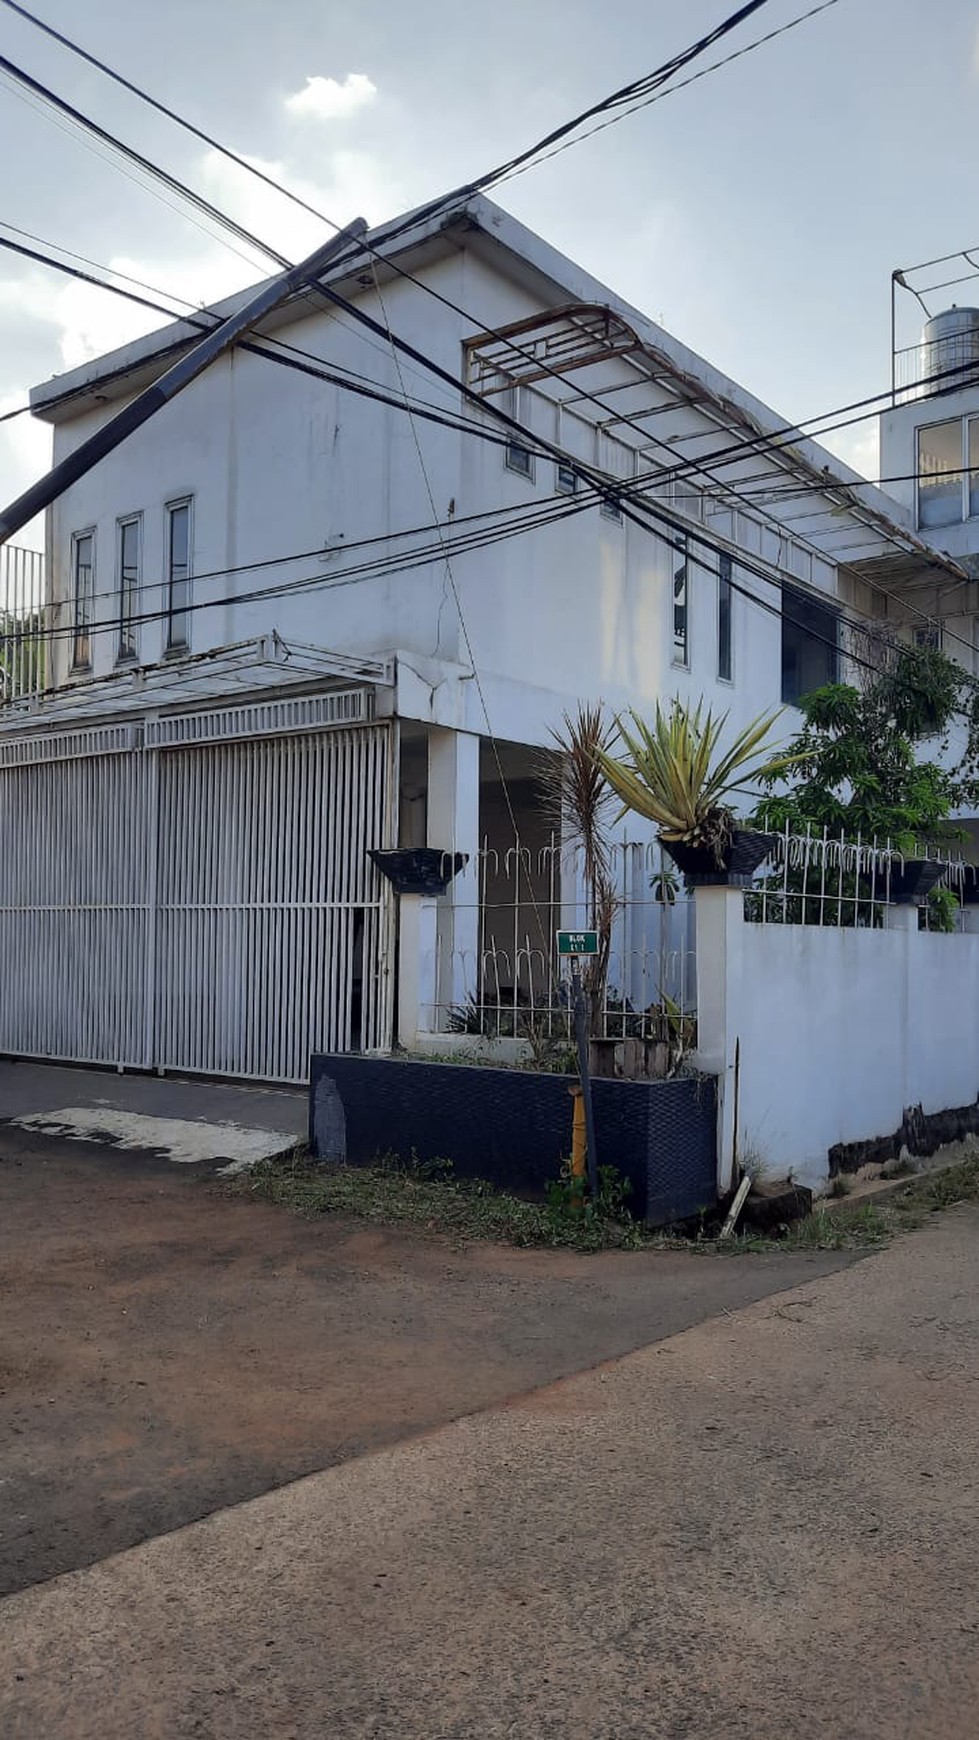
[{"x1": 596, "y1": 698, "x2": 791, "y2": 867}]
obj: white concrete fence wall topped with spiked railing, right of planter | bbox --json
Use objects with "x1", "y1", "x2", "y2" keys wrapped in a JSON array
[{"x1": 696, "y1": 887, "x2": 979, "y2": 1188}]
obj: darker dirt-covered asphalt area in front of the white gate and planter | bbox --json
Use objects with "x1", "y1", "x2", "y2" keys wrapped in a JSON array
[{"x1": 0, "y1": 1129, "x2": 847, "y2": 1594}]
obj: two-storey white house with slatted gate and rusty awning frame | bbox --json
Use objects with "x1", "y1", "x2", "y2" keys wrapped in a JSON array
[{"x1": 0, "y1": 198, "x2": 962, "y2": 1079}]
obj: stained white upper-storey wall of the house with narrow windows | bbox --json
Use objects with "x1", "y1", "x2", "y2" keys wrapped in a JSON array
[{"x1": 34, "y1": 224, "x2": 862, "y2": 743}]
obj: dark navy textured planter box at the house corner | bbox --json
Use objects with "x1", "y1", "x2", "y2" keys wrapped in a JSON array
[{"x1": 310, "y1": 1053, "x2": 716, "y2": 1227}]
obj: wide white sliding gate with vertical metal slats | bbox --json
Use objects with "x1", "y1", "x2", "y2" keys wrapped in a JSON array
[{"x1": 0, "y1": 696, "x2": 393, "y2": 1081}]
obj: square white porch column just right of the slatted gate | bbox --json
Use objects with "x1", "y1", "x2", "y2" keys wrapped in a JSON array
[{"x1": 428, "y1": 726, "x2": 480, "y2": 1032}]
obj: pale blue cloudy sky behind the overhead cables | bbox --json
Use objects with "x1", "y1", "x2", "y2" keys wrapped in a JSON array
[{"x1": 0, "y1": 0, "x2": 979, "y2": 545}]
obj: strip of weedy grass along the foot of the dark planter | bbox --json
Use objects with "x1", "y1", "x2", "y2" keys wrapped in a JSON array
[{"x1": 228, "y1": 1150, "x2": 979, "y2": 1256}]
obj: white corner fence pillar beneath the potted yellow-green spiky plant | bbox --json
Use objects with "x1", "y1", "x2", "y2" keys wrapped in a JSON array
[{"x1": 694, "y1": 887, "x2": 744, "y2": 1195}]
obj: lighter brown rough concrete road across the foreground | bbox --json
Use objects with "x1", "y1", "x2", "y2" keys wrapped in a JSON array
[{"x1": 7, "y1": 1206, "x2": 979, "y2": 1740}]
